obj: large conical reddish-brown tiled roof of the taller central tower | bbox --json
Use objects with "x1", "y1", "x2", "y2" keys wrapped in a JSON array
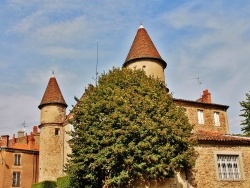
[{"x1": 123, "y1": 25, "x2": 167, "y2": 68}]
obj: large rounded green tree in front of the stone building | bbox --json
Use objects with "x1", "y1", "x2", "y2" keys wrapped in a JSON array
[{"x1": 66, "y1": 68, "x2": 195, "y2": 188}]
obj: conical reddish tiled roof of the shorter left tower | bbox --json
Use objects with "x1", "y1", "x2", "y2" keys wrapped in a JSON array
[{"x1": 38, "y1": 76, "x2": 67, "y2": 109}]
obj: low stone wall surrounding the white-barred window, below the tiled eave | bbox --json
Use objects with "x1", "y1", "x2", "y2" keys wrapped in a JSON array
[{"x1": 192, "y1": 145, "x2": 250, "y2": 188}]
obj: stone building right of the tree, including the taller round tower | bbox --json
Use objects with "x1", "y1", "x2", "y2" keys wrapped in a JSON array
[{"x1": 118, "y1": 26, "x2": 250, "y2": 188}]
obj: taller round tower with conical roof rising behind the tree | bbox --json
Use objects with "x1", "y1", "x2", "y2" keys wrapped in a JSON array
[{"x1": 123, "y1": 25, "x2": 167, "y2": 83}]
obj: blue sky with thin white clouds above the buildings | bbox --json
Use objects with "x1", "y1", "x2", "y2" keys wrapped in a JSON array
[{"x1": 0, "y1": 0, "x2": 250, "y2": 135}]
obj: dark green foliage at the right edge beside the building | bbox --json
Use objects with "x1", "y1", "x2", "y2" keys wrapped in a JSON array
[{"x1": 240, "y1": 93, "x2": 250, "y2": 135}]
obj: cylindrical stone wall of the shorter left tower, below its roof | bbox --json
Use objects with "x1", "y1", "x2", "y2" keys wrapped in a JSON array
[{"x1": 39, "y1": 104, "x2": 66, "y2": 182}]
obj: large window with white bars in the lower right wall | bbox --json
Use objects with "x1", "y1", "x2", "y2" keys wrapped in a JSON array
[{"x1": 217, "y1": 155, "x2": 241, "y2": 180}]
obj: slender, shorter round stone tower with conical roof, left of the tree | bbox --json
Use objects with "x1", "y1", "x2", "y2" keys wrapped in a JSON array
[{"x1": 38, "y1": 74, "x2": 67, "y2": 182}]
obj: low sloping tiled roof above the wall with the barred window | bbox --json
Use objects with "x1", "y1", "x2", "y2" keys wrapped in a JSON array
[{"x1": 196, "y1": 130, "x2": 250, "y2": 145}]
